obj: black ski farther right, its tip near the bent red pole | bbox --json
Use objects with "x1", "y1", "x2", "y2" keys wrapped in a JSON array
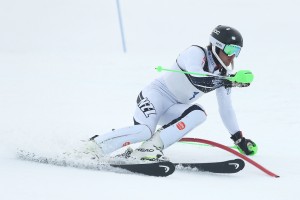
[{"x1": 174, "y1": 159, "x2": 245, "y2": 174}]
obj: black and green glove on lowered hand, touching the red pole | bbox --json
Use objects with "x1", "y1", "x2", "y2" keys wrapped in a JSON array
[{"x1": 230, "y1": 131, "x2": 257, "y2": 155}]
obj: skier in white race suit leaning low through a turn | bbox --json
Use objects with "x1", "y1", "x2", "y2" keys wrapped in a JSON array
[{"x1": 85, "y1": 25, "x2": 256, "y2": 161}]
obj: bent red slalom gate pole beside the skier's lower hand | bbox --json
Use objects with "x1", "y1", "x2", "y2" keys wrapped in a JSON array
[{"x1": 180, "y1": 138, "x2": 279, "y2": 178}]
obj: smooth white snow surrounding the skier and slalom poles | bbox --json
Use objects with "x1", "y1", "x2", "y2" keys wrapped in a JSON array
[{"x1": 0, "y1": 0, "x2": 300, "y2": 200}]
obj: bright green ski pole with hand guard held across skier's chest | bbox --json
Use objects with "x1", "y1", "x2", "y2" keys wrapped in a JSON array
[{"x1": 155, "y1": 66, "x2": 254, "y2": 83}]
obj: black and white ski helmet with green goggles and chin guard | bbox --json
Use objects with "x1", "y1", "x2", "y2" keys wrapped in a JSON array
[{"x1": 209, "y1": 25, "x2": 243, "y2": 70}]
